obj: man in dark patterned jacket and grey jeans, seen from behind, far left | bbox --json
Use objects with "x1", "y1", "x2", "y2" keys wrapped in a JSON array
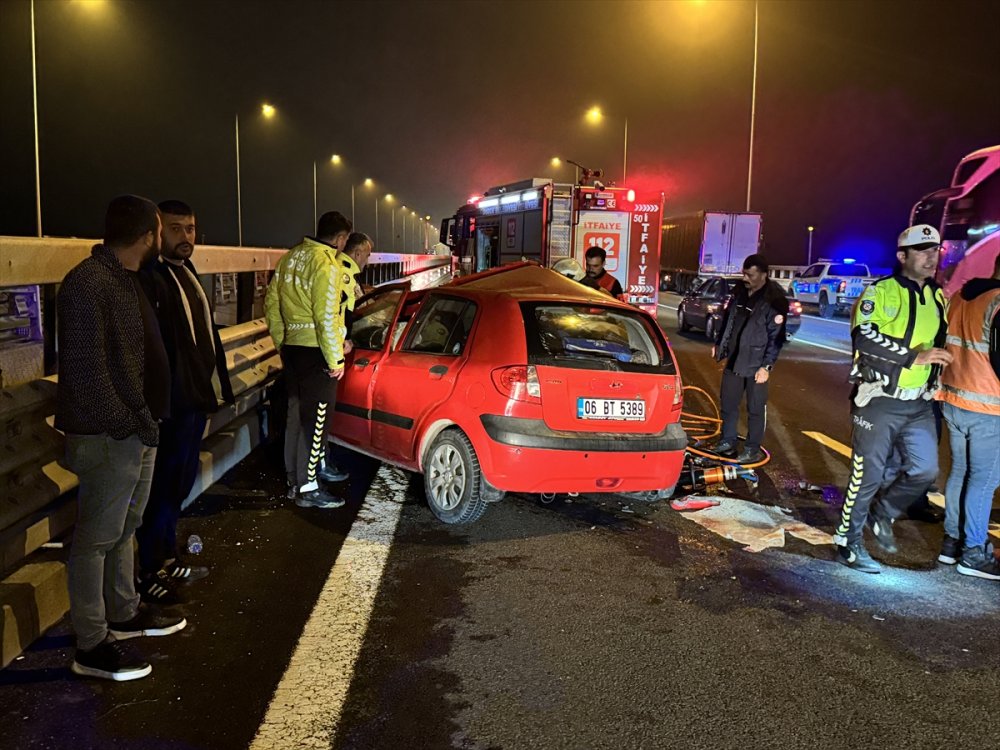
[{"x1": 55, "y1": 195, "x2": 187, "y2": 681}]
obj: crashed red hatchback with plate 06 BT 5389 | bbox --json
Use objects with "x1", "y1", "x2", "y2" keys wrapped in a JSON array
[{"x1": 331, "y1": 263, "x2": 687, "y2": 523}]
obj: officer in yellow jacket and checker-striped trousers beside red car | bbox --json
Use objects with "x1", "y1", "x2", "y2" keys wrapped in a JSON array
[{"x1": 264, "y1": 211, "x2": 353, "y2": 508}]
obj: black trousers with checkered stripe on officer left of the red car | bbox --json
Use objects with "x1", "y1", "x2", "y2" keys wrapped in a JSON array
[{"x1": 281, "y1": 345, "x2": 337, "y2": 492}]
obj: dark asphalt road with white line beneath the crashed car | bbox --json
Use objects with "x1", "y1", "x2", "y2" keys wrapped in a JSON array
[{"x1": 0, "y1": 300, "x2": 1000, "y2": 750}]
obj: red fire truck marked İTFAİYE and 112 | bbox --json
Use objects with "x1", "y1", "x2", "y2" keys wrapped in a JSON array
[{"x1": 441, "y1": 176, "x2": 663, "y2": 315}]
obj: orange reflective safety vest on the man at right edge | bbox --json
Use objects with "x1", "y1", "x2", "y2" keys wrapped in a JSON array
[{"x1": 936, "y1": 289, "x2": 1000, "y2": 416}]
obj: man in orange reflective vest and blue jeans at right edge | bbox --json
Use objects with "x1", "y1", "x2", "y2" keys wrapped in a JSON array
[{"x1": 936, "y1": 255, "x2": 1000, "y2": 581}]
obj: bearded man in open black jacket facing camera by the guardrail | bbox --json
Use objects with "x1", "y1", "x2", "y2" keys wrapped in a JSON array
[{"x1": 136, "y1": 200, "x2": 233, "y2": 604}]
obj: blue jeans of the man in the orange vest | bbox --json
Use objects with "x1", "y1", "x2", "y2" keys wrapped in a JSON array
[{"x1": 942, "y1": 402, "x2": 1000, "y2": 547}]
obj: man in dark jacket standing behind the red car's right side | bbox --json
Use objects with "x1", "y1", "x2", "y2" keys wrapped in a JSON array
[{"x1": 712, "y1": 254, "x2": 788, "y2": 464}]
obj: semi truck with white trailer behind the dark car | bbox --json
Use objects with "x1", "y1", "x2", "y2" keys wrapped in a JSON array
[{"x1": 660, "y1": 211, "x2": 762, "y2": 294}]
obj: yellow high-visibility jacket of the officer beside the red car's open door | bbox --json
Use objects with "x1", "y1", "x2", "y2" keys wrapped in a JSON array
[{"x1": 264, "y1": 237, "x2": 354, "y2": 369}]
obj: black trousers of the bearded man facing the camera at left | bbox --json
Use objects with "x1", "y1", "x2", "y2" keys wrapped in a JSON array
[{"x1": 135, "y1": 412, "x2": 207, "y2": 576}]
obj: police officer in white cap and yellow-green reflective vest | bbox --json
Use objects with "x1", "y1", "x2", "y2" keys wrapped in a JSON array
[{"x1": 833, "y1": 224, "x2": 952, "y2": 573}]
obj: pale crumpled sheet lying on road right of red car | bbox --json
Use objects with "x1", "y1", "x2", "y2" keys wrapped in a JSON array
[{"x1": 682, "y1": 495, "x2": 833, "y2": 552}]
